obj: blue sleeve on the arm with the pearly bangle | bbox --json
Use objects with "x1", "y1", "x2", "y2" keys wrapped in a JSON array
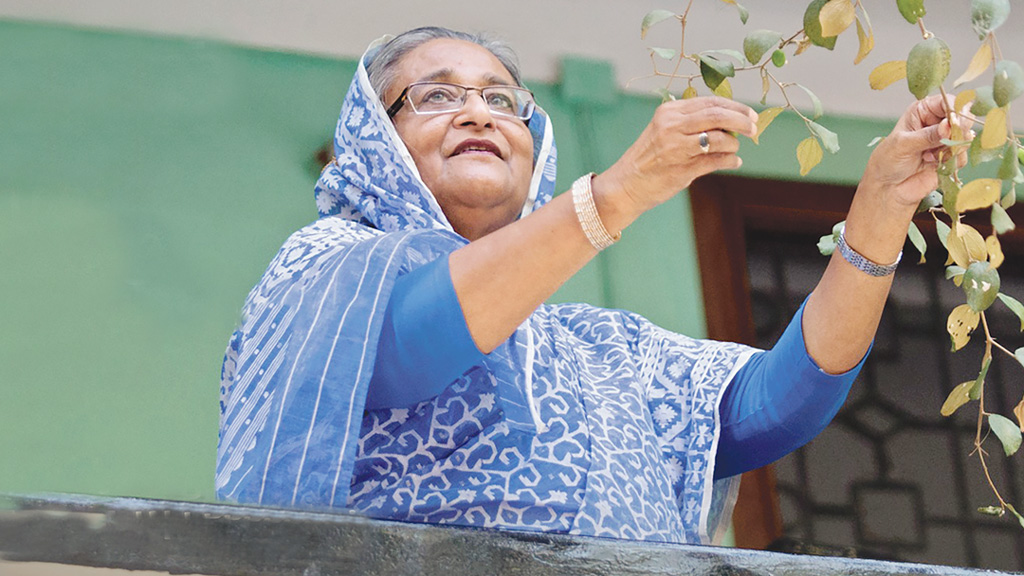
[{"x1": 367, "y1": 256, "x2": 485, "y2": 410}]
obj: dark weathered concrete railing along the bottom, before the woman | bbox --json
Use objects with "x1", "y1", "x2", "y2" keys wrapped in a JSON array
[{"x1": 0, "y1": 496, "x2": 999, "y2": 576}]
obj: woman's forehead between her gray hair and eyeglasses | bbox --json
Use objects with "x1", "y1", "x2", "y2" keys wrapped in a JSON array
[{"x1": 397, "y1": 38, "x2": 515, "y2": 89}]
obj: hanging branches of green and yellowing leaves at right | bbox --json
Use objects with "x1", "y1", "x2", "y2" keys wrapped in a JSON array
[{"x1": 641, "y1": 0, "x2": 1024, "y2": 526}]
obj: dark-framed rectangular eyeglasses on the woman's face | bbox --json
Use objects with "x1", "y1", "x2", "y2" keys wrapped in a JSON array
[{"x1": 387, "y1": 82, "x2": 535, "y2": 120}]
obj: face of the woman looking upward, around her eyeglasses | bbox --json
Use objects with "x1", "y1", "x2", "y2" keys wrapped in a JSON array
[{"x1": 384, "y1": 39, "x2": 534, "y2": 240}]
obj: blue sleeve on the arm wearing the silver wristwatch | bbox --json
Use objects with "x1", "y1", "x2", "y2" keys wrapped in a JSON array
[{"x1": 715, "y1": 300, "x2": 867, "y2": 479}]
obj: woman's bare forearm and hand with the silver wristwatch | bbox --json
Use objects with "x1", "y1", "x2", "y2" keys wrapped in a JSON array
[{"x1": 803, "y1": 95, "x2": 970, "y2": 374}]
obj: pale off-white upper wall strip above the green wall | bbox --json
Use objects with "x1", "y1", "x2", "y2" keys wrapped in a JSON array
[{"x1": 8, "y1": 0, "x2": 1024, "y2": 121}]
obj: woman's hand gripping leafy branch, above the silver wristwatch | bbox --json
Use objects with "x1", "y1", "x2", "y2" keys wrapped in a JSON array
[{"x1": 862, "y1": 94, "x2": 972, "y2": 207}]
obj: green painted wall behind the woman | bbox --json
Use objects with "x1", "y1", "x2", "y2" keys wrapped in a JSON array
[{"x1": 0, "y1": 22, "x2": 887, "y2": 500}]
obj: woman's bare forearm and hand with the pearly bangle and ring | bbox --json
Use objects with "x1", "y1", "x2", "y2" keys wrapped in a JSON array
[{"x1": 450, "y1": 97, "x2": 757, "y2": 354}]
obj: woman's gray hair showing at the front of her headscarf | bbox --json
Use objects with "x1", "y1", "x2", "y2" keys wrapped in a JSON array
[{"x1": 367, "y1": 26, "x2": 522, "y2": 106}]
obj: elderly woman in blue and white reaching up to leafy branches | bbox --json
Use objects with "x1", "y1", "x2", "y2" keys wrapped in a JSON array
[{"x1": 216, "y1": 28, "x2": 949, "y2": 542}]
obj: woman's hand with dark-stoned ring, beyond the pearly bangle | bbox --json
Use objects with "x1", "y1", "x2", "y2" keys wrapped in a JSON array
[{"x1": 593, "y1": 96, "x2": 758, "y2": 220}]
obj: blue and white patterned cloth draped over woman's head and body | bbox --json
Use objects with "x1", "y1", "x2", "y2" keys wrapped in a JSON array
[{"x1": 216, "y1": 36, "x2": 753, "y2": 542}]
